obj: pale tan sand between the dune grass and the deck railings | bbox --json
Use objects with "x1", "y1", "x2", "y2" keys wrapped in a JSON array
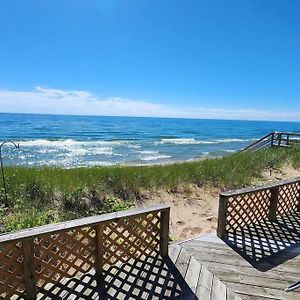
[{"x1": 137, "y1": 165, "x2": 300, "y2": 241}]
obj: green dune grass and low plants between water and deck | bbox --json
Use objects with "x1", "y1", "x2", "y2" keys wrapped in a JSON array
[{"x1": 0, "y1": 146, "x2": 300, "y2": 232}]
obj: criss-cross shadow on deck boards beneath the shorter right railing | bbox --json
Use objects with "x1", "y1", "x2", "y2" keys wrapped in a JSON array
[{"x1": 223, "y1": 212, "x2": 300, "y2": 271}]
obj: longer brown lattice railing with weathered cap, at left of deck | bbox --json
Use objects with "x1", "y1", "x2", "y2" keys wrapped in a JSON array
[{"x1": 0, "y1": 205, "x2": 170, "y2": 299}]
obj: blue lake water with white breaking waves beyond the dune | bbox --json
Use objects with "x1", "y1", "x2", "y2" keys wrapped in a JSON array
[{"x1": 0, "y1": 113, "x2": 300, "y2": 168}]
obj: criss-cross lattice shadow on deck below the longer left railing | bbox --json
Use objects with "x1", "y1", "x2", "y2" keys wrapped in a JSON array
[{"x1": 38, "y1": 256, "x2": 198, "y2": 300}]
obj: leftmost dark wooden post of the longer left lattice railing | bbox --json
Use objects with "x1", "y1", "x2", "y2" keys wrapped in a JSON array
[{"x1": 23, "y1": 239, "x2": 37, "y2": 300}]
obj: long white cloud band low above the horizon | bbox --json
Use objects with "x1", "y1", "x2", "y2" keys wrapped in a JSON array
[{"x1": 0, "y1": 86, "x2": 300, "y2": 121}]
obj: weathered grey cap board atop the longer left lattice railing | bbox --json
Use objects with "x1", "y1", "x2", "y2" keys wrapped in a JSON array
[{"x1": 0, "y1": 204, "x2": 170, "y2": 243}]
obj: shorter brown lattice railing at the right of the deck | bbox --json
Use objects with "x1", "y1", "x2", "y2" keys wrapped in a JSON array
[{"x1": 217, "y1": 178, "x2": 300, "y2": 238}]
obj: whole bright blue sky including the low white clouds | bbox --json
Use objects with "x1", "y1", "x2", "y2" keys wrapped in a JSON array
[{"x1": 0, "y1": 0, "x2": 300, "y2": 121}]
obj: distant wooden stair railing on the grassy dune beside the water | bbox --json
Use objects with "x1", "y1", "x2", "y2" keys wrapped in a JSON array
[{"x1": 240, "y1": 131, "x2": 300, "y2": 152}]
